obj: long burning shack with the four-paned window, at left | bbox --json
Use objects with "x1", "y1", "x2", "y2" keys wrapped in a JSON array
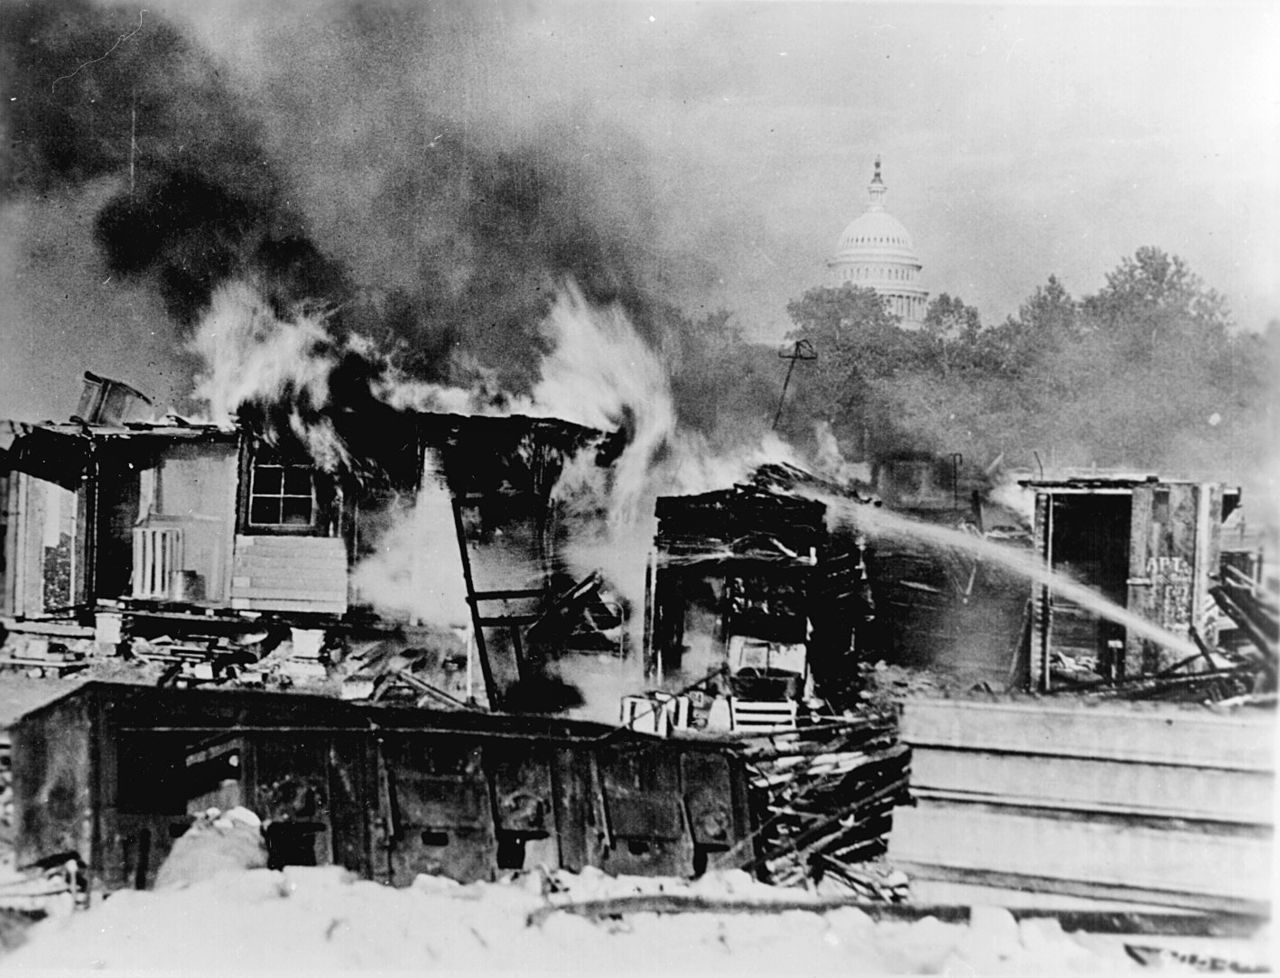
[{"x1": 0, "y1": 378, "x2": 608, "y2": 708}]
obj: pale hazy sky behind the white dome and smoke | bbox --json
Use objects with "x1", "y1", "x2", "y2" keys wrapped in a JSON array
[{"x1": 0, "y1": 0, "x2": 1280, "y2": 416}]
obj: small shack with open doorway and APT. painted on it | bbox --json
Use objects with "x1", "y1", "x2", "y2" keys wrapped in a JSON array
[{"x1": 1021, "y1": 476, "x2": 1240, "y2": 691}]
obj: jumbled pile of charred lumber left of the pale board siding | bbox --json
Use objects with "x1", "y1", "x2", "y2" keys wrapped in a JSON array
[{"x1": 744, "y1": 713, "x2": 911, "y2": 900}]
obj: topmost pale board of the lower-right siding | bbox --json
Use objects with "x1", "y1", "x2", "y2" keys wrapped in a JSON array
[{"x1": 901, "y1": 699, "x2": 1275, "y2": 772}]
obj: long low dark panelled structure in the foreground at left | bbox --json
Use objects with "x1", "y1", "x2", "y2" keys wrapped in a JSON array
[{"x1": 12, "y1": 682, "x2": 753, "y2": 891}]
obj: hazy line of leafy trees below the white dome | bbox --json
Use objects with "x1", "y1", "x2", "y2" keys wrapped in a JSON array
[{"x1": 673, "y1": 247, "x2": 1280, "y2": 481}]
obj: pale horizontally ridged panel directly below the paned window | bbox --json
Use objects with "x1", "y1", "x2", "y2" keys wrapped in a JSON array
[{"x1": 232, "y1": 535, "x2": 347, "y2": 614}]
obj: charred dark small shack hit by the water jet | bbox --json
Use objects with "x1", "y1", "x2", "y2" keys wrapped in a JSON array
[{"x1": 645, "y1": 465, "x2": 872, "y2": 731}]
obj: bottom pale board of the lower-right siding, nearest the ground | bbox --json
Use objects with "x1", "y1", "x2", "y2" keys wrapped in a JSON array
[{"x1": 888, "y1": 801, "x2": 1272, "y2": 905}]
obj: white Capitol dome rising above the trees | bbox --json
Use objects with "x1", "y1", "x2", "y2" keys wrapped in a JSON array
[{"x1": 827, "y1": 156, "x2": 929, "y2": 329}]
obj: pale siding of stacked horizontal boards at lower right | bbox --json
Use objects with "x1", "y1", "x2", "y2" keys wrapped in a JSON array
[{"x1": 888, "y1": 700, "x2": 1276, "y2": 913}]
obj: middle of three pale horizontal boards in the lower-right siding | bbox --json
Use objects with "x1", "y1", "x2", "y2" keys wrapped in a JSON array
[{"x1": 911, "y1": 748, "x2": 1275, "y2": 824}]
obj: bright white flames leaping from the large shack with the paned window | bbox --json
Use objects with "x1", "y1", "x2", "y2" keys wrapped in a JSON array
[{"x1": 192, "y1": 275, "x2": 796, "y2": 712}]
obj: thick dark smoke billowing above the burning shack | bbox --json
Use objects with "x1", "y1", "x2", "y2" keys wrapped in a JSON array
[{"x1": 3, "y1": 0, "x2": 711, "y2": 409}]
